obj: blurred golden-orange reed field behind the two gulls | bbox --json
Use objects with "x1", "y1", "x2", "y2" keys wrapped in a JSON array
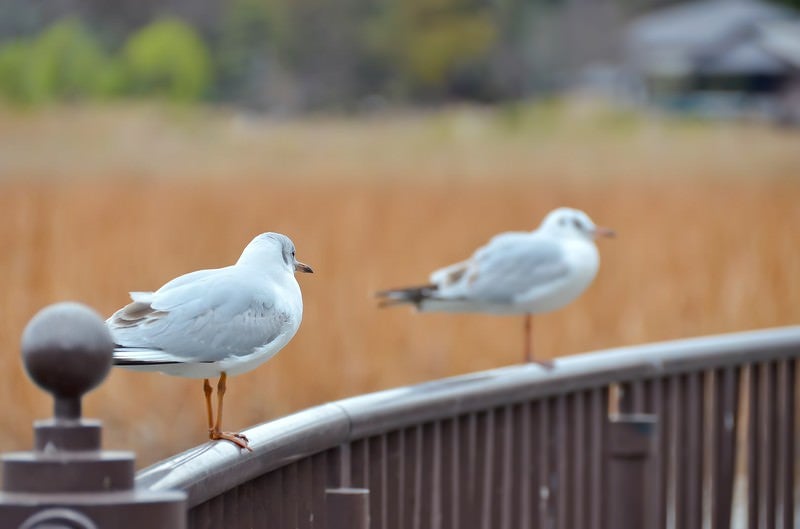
[{"x1": 0, "y1": 104, "x2": 800, "y2": 466}]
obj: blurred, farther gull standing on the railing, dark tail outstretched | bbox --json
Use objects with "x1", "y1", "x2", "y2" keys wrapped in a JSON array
[{"x1": 377, "y1": 208, "x2": 614, "y2": 367}]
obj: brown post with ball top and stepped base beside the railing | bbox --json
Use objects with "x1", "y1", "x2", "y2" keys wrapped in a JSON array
[{"x1": 0, "y1": 303, "x2": 186, "y2": 529}]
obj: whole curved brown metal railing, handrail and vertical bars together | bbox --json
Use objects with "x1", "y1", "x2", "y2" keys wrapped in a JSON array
[{"x1": 136, "y1": 327, "x2": 800, "y2": 529}]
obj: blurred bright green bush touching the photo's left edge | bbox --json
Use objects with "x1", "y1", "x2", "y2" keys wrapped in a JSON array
[{"x1": 0, "y1": 19, "x2": 115, "y2": 105}]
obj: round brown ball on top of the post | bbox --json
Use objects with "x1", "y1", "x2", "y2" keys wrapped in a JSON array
[{"x1": 22, "y1": 302, "x2": 114, "y2": 399}]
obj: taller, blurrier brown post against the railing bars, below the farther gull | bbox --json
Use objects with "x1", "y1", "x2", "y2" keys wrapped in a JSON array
[{"x1": 606, "y1": 415, "x2": 657, "y2": 529}]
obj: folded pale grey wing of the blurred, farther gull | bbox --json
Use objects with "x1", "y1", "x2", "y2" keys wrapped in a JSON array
[{"x1": 436, "y1": 232, "x2": 569, "y2": 303}]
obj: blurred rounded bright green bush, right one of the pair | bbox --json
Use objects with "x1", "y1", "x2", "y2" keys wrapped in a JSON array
[{"x1": 123, "y1": 19, "x2": 212, "y2": 102}]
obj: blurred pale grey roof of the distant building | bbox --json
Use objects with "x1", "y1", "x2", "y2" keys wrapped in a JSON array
[{"x1": 626, "y1": 0, "x2": 800, "y2": 76}]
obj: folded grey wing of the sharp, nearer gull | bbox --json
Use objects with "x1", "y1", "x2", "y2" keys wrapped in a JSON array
[{"x1": 107, "y1": 267, "x2": 293, "y2": 363}]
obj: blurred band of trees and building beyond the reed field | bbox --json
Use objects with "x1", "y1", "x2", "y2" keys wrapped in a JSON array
[{"x1": 0, "y1": 0, "x2": 800, "y2": 112}]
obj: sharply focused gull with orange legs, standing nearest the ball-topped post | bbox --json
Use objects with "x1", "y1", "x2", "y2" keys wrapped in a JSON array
[{"x1": 106, "y1": 233, "x2": 313, "y2": 450}]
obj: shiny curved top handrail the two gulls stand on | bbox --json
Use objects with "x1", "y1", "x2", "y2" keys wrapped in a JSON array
[{"x1": 136, "y1": 326, "x2": 800, "y2": 508}]
